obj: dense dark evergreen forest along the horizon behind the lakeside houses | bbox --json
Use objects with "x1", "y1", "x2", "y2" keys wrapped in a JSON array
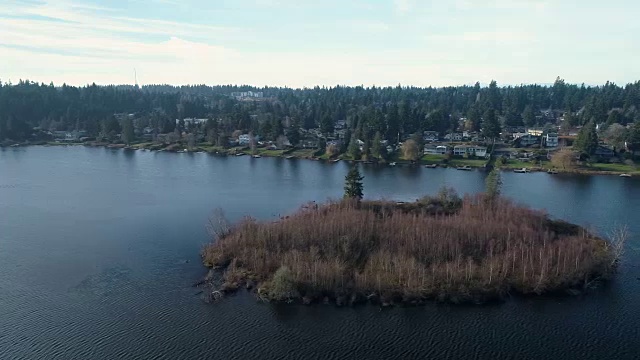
[{"x1": 0, "y1": 78, "x2": 640, "y2": 142}]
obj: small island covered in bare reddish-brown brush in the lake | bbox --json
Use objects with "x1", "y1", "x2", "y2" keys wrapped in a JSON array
[{"x1": 202, "y1": 194, "x2": 615, "y2": 304}]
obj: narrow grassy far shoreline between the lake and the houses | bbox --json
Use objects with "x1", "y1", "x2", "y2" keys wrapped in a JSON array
[{"x1": 0, "y1": 141, "x2": 640, "y2": 178}]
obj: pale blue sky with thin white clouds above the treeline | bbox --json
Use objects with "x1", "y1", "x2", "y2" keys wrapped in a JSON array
[{"x1": 0, "y1": 0, "x2": 640, "y2": 87}]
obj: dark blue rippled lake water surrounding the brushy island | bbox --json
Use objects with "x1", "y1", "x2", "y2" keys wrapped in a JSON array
[{"x1": 0, "y1": 147, "x2": 640, "y2": 359}]
